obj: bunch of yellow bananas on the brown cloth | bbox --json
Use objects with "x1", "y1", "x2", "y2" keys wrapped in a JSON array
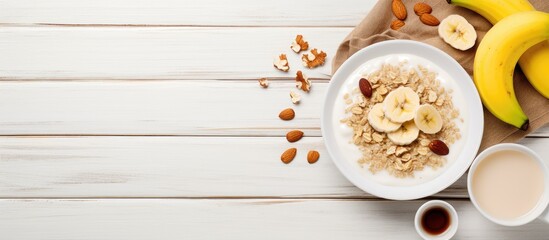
[{"x1": 447, "y1": 0, "x2": 549, "y2": 130}]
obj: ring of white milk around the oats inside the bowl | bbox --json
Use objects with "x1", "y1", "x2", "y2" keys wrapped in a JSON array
[{"x1": 332, "y1": 54, "x2": 471, "y2": 186}]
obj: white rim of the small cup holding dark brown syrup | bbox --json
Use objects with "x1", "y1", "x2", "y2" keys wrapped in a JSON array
[{"x1": 414, "y1": 200, "x2": 459, "y2": 240}]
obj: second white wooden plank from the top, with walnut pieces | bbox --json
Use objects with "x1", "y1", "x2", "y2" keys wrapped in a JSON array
[{"x1": 0, "y1": 27, "x2": 351, "y2": 80}]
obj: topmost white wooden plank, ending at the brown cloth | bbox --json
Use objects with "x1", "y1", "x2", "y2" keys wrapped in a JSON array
[{"x1": 0, "y1": 0, "x2": 376, "y2": 26}]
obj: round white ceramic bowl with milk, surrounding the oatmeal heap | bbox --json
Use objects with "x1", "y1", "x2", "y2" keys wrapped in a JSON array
[{"x1": 321, "y1": 40, "x2": 484, "y2": 200}]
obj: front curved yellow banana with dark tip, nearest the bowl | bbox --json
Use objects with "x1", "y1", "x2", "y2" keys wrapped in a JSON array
[{"x1": 473, "y1": 11, "x2": 549, "y2": 130}]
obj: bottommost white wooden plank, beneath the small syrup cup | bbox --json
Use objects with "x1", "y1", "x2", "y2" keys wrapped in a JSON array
[{"x1": 0, "y1": 199, "x2": 547, "y2": 240}]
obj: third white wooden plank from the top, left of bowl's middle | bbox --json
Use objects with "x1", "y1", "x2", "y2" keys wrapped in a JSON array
[{"x1": 4, "y1": 80, "x2": 549, "y2": 137}]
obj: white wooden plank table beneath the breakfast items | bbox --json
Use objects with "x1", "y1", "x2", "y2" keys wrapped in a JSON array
[{"x1": 0, "y1": 0, "x2": 549, "y2": 240}]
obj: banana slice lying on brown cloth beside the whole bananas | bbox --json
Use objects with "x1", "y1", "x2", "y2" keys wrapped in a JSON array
[{"x1": 438, "y1": 14, "x2": 477, "y2": 51}]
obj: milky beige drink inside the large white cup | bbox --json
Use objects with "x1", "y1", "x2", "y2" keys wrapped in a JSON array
[{"x1": 471, "y1": 150, "x2": 545, "y2": 220}]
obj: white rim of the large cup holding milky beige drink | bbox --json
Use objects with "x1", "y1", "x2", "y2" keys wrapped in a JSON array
[{"x1": 467, "y1": 143, "x2": 549, "y2": 226}]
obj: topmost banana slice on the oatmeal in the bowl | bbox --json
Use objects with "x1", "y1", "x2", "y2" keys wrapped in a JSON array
[{"x1": 383, "y1": 87, "x2": 419, "y2": 123}]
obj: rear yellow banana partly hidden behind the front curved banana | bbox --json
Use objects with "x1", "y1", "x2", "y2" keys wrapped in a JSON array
[{"x1": 447, "y1": 0, "x2": 549, "y2": 98}]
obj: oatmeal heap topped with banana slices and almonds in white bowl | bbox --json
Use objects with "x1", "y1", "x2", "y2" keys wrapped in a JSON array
[{"x1": 340, "y1": 61, "x2": 463, "y2": 178}]
